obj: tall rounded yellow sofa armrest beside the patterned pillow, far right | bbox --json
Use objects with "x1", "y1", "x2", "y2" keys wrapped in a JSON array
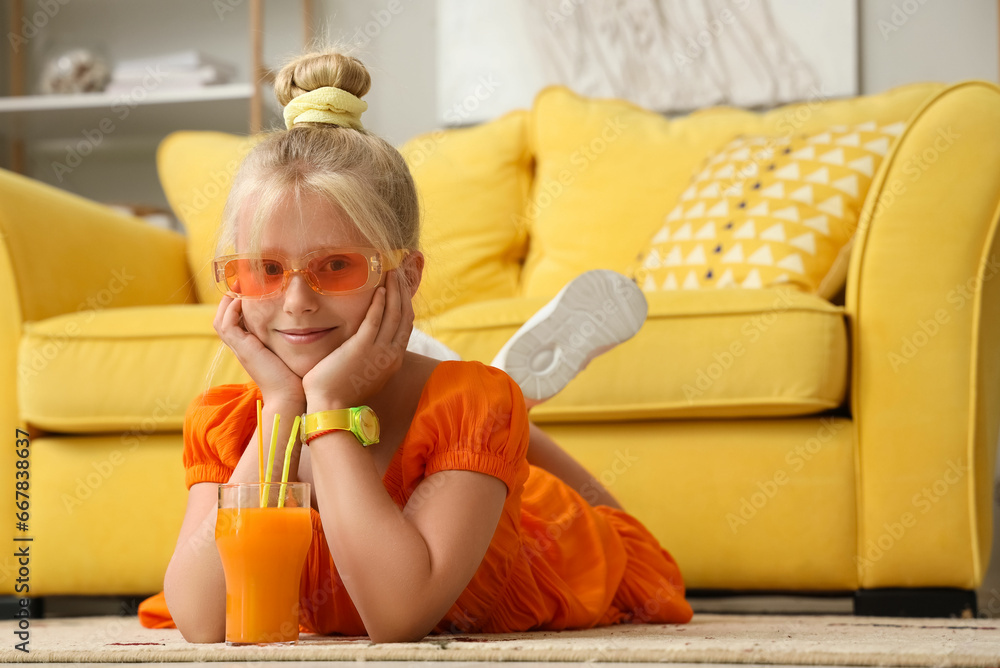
[{"x1": 845, "y1": 81, "x2": 1000, "y2": 589}]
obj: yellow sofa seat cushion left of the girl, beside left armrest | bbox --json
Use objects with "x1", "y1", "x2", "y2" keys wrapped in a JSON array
[{"x1": 18, "y1": 304, "x2": 250, "y2": 434}]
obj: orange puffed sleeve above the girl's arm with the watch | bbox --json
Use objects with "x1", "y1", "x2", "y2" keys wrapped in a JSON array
[{"x1": 424, "y1": 362, "x2": 528, "y2": 498}]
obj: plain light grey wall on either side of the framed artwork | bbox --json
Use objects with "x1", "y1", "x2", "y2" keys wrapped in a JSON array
[{"x1": 316, "y1": 0, "x2": 1000, "y2": 145}]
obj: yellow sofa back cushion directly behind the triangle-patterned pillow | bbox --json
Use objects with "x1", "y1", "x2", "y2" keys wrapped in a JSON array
[{"x1": 521, "y1": 83, "x2": 944, "y2": 296}]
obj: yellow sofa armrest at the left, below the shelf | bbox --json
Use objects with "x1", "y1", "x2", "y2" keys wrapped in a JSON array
[{"x1": 0, "y1": 170, "x2": 194, "y2": 322}]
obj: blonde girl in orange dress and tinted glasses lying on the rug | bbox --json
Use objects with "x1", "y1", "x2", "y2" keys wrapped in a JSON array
[{"x1": 140, "y1": 52, "x2": 692, "y2": 642}]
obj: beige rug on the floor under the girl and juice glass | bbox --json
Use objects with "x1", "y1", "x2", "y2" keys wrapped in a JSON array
[{"x1": 0, "y1": 613, "x2": 1000, "y2": 667}]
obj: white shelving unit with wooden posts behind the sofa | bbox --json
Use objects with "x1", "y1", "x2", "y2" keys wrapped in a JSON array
[{"x1": 0, "y1": 0, "x2": 313, "y2": 209}]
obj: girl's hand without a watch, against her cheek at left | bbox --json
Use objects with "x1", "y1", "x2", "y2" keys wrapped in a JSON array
[{"x1": 212, "y1": 295, "x2": 305, "y2": 403}]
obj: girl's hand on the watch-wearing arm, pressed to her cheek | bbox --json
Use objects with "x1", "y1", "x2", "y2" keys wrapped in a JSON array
[{"x1": 302, "y1": 269, "x2": 413, "y2": 408}]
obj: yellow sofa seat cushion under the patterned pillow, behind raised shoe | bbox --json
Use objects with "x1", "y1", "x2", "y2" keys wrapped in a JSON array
[{"x1": 418, "y1": 286, "x2": 848, "y2": 422}]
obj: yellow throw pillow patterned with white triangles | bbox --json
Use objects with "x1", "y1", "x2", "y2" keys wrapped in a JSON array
[{"x1": 634, "y1": 122, "x2": 904, "y2": 298}]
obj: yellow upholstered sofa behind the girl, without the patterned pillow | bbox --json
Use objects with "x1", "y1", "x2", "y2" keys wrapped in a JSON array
[{"x1": 0, "y1": 82, "x2": 1000, "y2": 614}]
